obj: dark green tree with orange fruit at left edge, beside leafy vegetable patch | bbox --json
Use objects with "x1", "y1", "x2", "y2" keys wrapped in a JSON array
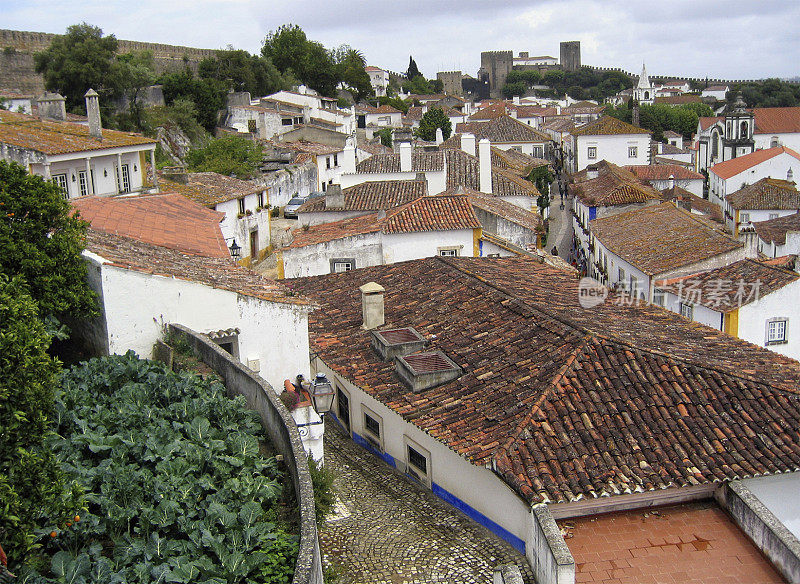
[{"x1": 0, "y1": 274, "x2": 82, "y2": 571}]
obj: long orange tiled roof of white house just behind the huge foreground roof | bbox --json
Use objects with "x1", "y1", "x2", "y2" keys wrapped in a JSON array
[{"x1": 289, "y1": 195, "x2": 481, "y2": 248}]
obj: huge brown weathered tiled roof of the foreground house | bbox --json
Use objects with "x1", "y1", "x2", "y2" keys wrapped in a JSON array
[{"x1": 293, "y1": 258, "x2": 800, "y2": 503}]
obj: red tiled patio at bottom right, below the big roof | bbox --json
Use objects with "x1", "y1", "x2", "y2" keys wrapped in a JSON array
[{"x1": 558, "y1": 501, "x2": 785, "y2": 584}]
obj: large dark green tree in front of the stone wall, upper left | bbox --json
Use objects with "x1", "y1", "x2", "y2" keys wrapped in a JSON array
[{"x1": 33, "y1": 22, "x2": 120, "y2": 111}]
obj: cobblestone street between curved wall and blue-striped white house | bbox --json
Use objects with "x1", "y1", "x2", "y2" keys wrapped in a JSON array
[{"x1": 320, "y1": 423, "x2": 534, "y2": 584}]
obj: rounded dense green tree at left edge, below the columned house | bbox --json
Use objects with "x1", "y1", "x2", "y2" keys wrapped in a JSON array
[{"x1": 0, "y1": 160, "x2": 96, "y2": 318}]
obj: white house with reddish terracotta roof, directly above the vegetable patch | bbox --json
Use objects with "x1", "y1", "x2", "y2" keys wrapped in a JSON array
[{"x1": 73, "y1": 195, "x2": 311, "y2": 393}]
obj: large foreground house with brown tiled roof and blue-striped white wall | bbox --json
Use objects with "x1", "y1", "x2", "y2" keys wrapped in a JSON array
[{"x1": 292, "y1": 257, "x2": 800, "y2": 584}]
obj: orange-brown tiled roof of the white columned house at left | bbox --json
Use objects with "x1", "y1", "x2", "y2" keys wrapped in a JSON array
[{"x1": 0, "y1": 110, "x2": 156, "y2": 155}]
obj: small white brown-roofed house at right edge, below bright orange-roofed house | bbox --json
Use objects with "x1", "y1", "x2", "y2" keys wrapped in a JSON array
[{"x1": 724, "y1": 178, "x2": 800, "y2": 237}]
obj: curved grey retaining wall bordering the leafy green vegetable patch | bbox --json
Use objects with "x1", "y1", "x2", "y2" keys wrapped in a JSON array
[{"x1": 169, "y1": 324, "x2": 323, "y2": 584}]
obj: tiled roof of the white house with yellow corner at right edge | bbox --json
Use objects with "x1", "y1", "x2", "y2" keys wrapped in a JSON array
[{"x1": 655, "y1": 259, "x2": 800, "y2": 313}]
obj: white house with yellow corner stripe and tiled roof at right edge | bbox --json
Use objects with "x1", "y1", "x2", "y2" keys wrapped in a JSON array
[{"x1": 656, "y1": 259, "x2": 800, "y2": 359}]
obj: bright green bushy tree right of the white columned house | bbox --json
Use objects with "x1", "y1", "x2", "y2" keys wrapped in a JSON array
[{"x1": 186, "y1": 135, "x2": 264, "y2": 178}]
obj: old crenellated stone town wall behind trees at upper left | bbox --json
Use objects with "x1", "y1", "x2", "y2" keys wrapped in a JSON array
[{"x1": 0, "y1": 29, "x2": 217, "y2": 95}]
